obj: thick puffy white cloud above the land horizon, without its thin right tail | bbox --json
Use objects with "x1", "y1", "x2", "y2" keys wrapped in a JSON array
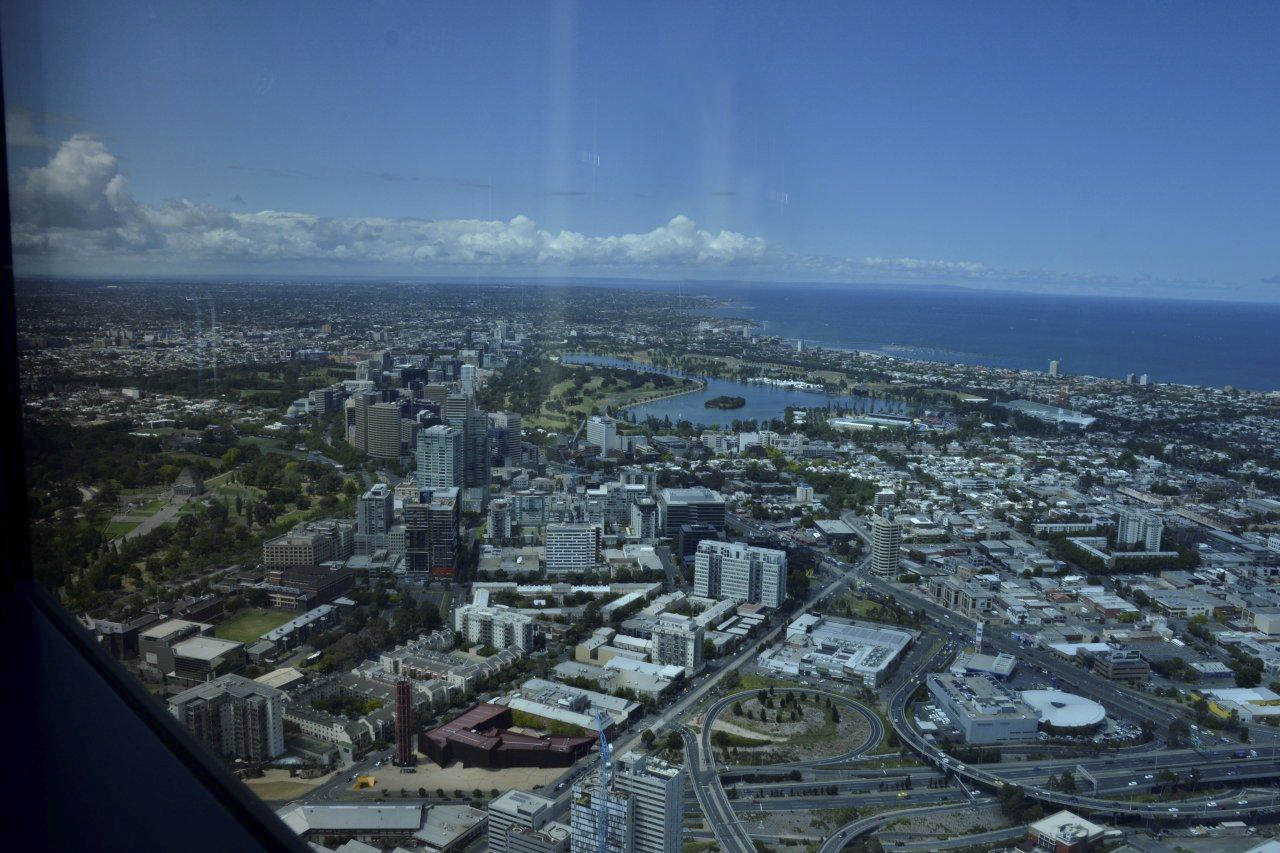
[{"x1": 14, "y1": 134, "x2": 783, "y2": 268}]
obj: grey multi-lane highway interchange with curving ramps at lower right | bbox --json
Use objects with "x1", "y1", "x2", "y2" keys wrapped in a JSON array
[{"x1": 682, "y1": 519, "x2": 1280, "y2": 853}]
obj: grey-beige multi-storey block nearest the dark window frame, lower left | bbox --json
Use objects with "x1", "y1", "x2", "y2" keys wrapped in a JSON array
[{"x1": 169, "y1": 675, "x2": 284, "y2": 761}]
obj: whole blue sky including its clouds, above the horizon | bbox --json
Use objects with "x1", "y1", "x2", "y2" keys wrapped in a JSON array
[{"x1": 0, "y1": 1, "x2": 1280, "y2": 300}]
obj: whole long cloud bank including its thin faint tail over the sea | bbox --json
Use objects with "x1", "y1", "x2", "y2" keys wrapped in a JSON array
[{"x1": 9, "y1": 133, "x2": 1218, "y2": 298}]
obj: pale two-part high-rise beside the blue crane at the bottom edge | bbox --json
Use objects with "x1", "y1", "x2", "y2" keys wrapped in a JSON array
[{"x1": 570, "y1": 752, "x2": 685, "y2": 853}]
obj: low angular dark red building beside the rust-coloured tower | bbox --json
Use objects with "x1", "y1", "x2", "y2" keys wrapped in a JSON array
[{"x1": 419, "y1": 702, "x2": 595, "y2": 768}]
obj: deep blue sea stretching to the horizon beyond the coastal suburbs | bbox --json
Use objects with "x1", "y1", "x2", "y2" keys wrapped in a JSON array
[{"x1": 616, "y1": 282, "x2": 1280, "y2": 391}]
